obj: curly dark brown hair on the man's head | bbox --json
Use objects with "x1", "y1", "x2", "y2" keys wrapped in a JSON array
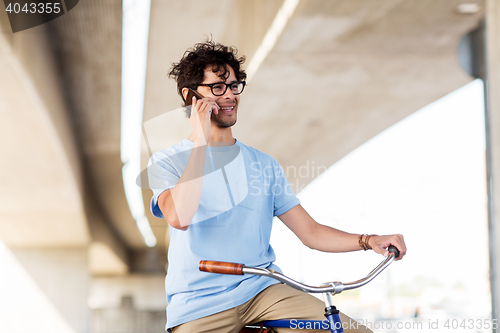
[{"x1": 168, "y1": 40, "x2": 247, "y2": 101}]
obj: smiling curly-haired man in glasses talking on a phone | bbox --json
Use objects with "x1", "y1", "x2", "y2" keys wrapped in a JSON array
[{"x1": 150, "y1": 41, "x2": 406, "y2": 333}]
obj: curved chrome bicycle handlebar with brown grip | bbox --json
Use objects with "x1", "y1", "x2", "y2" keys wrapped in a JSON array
[{"x1": 199, "y1": 245, "x2": 399, "y2": 294}]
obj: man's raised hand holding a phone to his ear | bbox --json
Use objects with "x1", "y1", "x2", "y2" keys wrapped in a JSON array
[{"x1": 189, "y1": 97, "x2": 219, "y2": 145}]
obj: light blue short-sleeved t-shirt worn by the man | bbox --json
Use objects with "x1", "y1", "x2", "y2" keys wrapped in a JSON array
[{"x1": 148, "y1": 139, "x2": 299, "y2": 328}]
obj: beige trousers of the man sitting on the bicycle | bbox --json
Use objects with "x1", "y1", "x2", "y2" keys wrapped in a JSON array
[{"x1": 172, "y1": 284, "x2": 371, "y2": 333}]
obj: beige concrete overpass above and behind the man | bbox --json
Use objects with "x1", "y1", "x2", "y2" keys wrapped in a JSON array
[{"x1": 0, "y1": 0, "x2": 500, "y2": 332}]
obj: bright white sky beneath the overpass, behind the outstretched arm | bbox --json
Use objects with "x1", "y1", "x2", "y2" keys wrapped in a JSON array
[{"x1": 271, "y1": 80, "x2": 490, "y2": 315}]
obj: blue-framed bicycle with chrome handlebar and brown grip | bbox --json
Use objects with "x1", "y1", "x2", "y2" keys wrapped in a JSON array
[{"x1": 199, "y1": 245, "x2": 399, "y2": 333}]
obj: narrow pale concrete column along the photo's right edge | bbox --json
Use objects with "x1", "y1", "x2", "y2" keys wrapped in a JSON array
[{"x1": 486, "y1": 0, "x2": 500, "y2": 332}]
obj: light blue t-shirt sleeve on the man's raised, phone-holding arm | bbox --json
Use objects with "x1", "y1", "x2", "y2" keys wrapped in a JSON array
[{"x1": 148, "y1": 152, "x2": 181, "y2": 218}]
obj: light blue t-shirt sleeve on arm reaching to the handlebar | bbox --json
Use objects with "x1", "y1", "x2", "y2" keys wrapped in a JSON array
[{"x1": 272, "y1": 159, "x2": 300, "y2": 216}]
